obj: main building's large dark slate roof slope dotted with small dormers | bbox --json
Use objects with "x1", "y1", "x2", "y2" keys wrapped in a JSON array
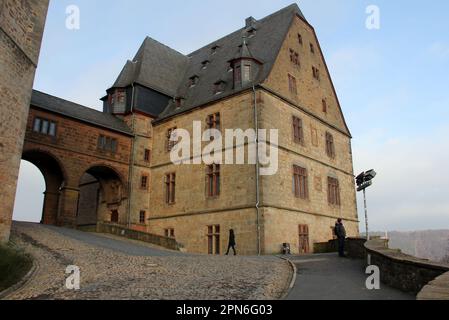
[{"x1": 156, "y1": 4, "x2": 304, "y2": 122}]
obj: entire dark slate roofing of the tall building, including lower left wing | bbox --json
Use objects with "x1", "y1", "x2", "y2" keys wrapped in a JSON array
[{"x1": 113, "y1": 4, "x2": 305, "y2": 121}]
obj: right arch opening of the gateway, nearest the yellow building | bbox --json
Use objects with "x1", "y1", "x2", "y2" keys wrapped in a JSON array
[{"x1": 76, "y1": 164, "x2": 127, "y2": 226}]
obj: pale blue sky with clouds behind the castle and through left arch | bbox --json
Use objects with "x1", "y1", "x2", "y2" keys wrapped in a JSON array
[{"x1": 14, "y1": 0, "x2": 449, "y2": 231}]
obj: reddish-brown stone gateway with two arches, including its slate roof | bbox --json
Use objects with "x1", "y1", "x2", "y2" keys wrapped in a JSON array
[{"x1": 22, "y1": 91, "x2": 132, "y2": 227}]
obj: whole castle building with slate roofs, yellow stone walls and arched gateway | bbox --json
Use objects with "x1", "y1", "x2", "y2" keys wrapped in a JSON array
[{"x1": 0, "y1": 4, "x2": 358, "y2": 255}]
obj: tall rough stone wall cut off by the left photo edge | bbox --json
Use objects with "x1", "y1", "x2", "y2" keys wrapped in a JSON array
[{"x1": 0, "y1": 0, "x2": 48, "y2": 242}]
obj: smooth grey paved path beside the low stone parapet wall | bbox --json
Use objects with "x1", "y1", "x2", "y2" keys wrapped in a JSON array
[{"x1": 287, "y1": 254, "x2": 415, "y2": 300}]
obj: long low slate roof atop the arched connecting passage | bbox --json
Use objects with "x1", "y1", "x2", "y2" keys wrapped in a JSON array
[{"x1": 31, "y1": 90, "x2": 133, "y2": 135}]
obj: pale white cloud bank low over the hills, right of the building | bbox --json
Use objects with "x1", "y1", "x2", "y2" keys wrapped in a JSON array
[{"x1": 354, "y1": 127, "x2": 449, "y2": 230}]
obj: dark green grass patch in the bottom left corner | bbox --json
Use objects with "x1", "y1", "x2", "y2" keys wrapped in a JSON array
[{"x1": 0, "y1": 245, "x2": 33, "y2": 292}]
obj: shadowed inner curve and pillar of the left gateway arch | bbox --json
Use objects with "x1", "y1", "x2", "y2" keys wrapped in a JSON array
[{"x1": 22, "y1": 150, "x2": 66, "y2": 225}]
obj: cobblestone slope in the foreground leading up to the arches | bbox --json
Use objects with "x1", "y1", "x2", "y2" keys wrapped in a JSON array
[{"x1": 7, "y1": 223, "x2": 291, "y2": 300}]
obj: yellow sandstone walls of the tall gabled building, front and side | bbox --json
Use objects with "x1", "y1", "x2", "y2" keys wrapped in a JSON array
[{"x1": 143, "y1": 17, "x2": 359, "y2": 254}]
